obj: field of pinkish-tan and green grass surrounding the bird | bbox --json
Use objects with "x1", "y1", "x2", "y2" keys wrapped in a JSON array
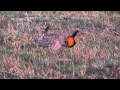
[{"x1": 0, "y1": 11, "x2": 120, "y2": 79}]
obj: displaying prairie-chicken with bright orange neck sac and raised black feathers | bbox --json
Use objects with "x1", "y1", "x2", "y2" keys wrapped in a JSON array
[{"x1": 39, "y1": 27, "x2": 78, "y2": 52}]
